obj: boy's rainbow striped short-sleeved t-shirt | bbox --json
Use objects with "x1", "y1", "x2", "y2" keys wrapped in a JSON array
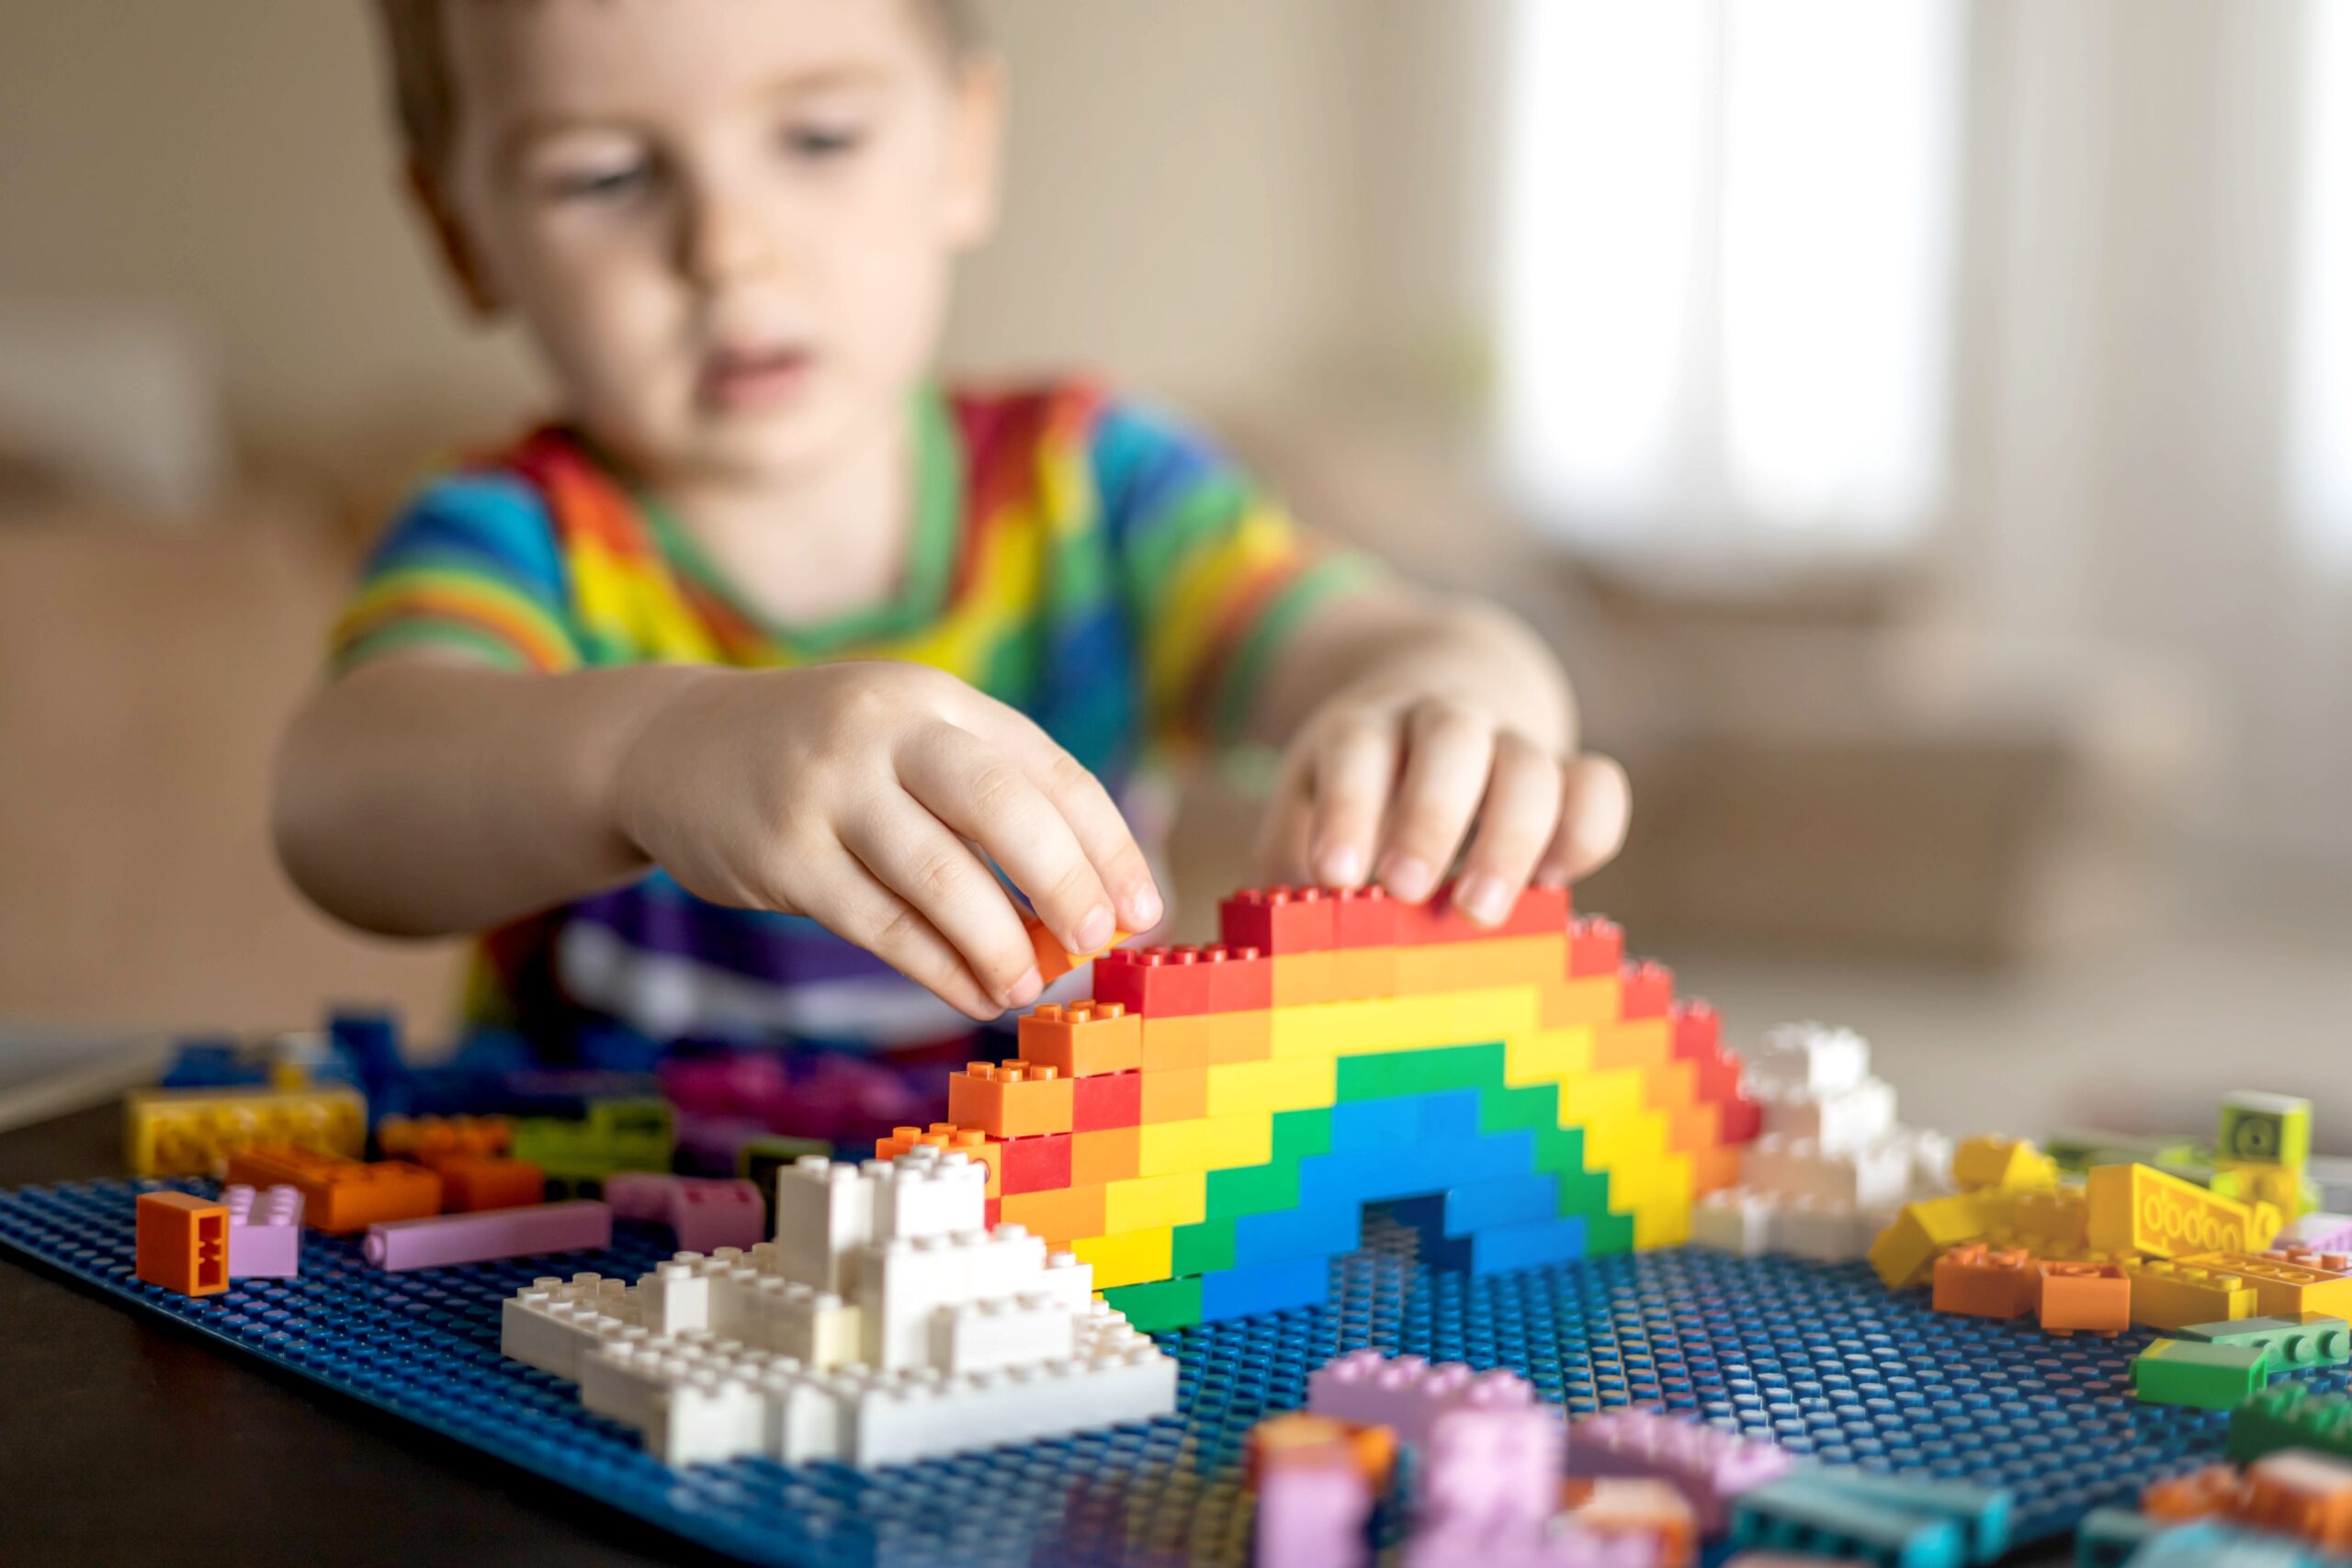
[{"x1": 334, "y1": 386, "x2": 1362, "y2": 1055}]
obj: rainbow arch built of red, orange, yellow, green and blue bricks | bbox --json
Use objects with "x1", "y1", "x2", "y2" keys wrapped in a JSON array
[{"x1": 877, "y1": 888, "x2": 1757, "y2": 1328}]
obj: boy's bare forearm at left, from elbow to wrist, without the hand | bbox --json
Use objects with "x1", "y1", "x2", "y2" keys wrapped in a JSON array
[{"x1": 276, "y1": 659, "x2": 710, "y2": 936}]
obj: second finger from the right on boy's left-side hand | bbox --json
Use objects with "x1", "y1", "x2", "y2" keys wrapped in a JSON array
[{"x1": 899, "y1": 724, "x2": 1120, "y2": 952}]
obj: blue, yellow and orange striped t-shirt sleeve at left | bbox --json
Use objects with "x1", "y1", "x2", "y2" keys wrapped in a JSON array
[{"x1": 329, "y1": 472, "x2": 581, "y2": 672}]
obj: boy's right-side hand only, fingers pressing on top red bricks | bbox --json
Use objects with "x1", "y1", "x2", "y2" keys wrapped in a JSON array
[{"x1": 1261, "y1": 660, "x2": 1630, "y2": 926}]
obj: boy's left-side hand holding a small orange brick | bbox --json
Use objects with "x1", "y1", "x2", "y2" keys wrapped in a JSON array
[{"x1": 612, "y1": 663, "x2": 1162, "y2": 1018}]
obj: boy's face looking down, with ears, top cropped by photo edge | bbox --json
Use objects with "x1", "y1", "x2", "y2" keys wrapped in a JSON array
[{"x1": 424, "y1": 0, "x2": 997, "y2": 479}]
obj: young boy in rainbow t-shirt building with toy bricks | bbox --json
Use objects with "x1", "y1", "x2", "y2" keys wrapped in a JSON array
[{"x1": 277, "y1": 0, "x2": 1628, "y2": 1066}]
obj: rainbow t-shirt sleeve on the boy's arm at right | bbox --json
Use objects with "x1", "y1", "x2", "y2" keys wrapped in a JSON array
[{"x1": 1093, "y1": 404, "x2": 1374, "y2": 745}]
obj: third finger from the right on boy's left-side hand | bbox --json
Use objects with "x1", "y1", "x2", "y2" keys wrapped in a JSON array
[{"x1": 842, "y1": 795, "x2": 1045, "y2": 1016}]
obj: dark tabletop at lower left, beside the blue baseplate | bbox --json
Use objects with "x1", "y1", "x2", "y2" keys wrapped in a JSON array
[{"x1": 0, "y1": 1105, "x2": 719, "y2": 1568}]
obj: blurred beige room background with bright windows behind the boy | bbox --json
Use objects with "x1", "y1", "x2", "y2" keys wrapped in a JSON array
[{"x1": 0, "y1": 0, "x2": 2352, "y2": 1152}]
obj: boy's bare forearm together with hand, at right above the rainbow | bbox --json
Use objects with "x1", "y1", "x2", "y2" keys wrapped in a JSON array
[{"x1": 1247, "y1": 581, "x2": 1630, "y2": 924}]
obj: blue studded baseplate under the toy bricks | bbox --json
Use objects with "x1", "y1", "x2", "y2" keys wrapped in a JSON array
[{"x1": 0, "y1": 1182, "x2": 2347, "y2": 1568}]
